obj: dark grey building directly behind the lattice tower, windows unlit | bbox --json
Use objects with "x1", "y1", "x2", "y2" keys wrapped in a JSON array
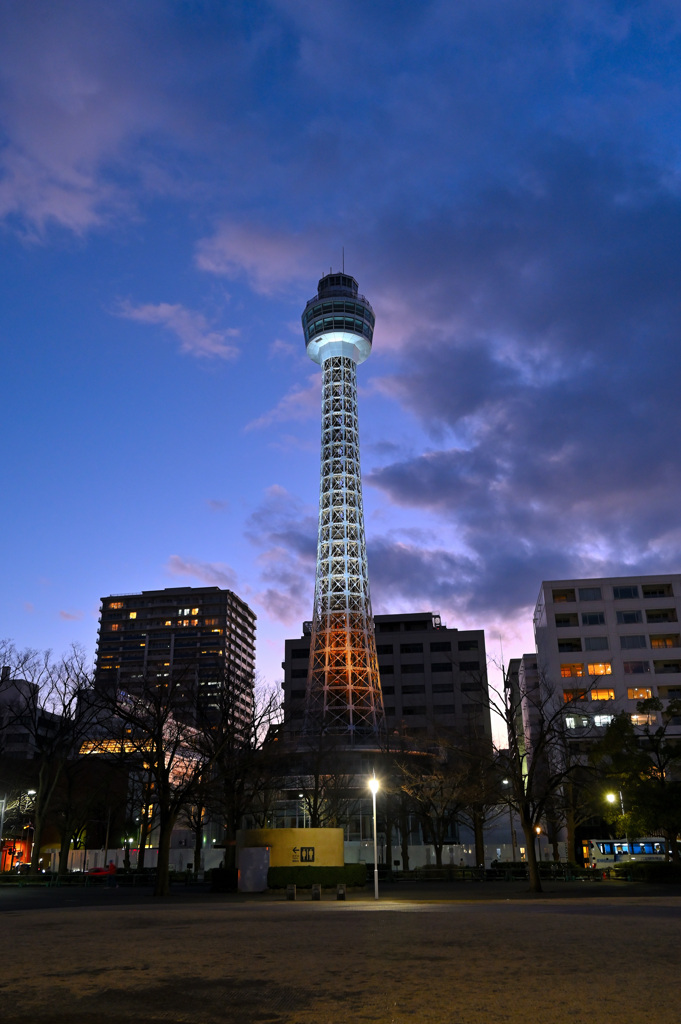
[{"x1": 282, "y1": 611, "x2": 492, "y2": 743}]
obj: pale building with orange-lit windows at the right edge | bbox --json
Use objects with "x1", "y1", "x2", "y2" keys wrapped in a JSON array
[{"x1": 535, "y1": 574, "x2": 681, "y2": 741}]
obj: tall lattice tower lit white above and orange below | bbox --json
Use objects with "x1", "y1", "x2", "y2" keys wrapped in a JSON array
[{"x1": 302, "y1": 273, "x2": 385, "y2": 745}]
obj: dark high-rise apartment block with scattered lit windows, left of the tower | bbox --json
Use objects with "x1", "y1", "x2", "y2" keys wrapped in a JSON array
[{"x1": 95, "y1": 587, "x2": 256, "y2": 723}]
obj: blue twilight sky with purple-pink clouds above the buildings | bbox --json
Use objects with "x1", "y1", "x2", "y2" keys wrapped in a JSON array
[{"x1": 0, "y1": 0, "x2": 681, "y2": 696}]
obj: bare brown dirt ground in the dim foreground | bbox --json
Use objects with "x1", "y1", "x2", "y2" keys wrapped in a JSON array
[{"x1": 0, "y1": 888, "x2": 681, "y2": 1024}]
